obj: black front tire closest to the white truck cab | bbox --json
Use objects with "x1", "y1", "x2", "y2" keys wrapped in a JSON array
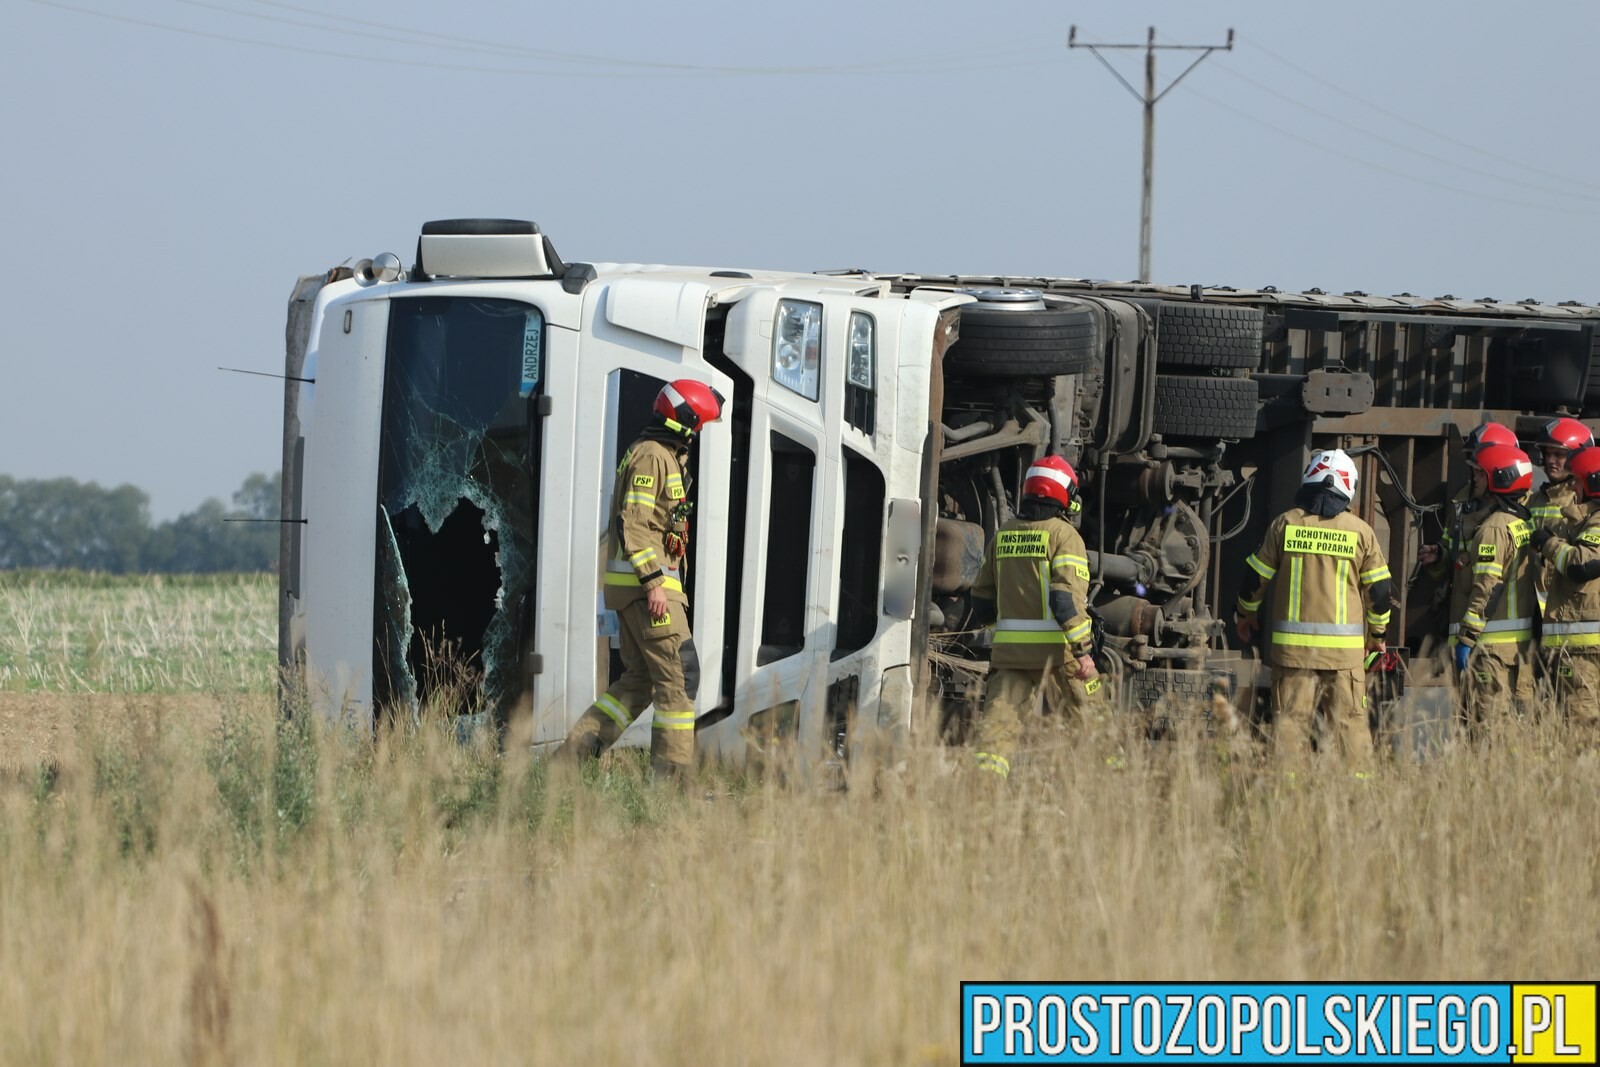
[{"x1": 944, "y1": 304, "x2": 1099, "y2": 378}]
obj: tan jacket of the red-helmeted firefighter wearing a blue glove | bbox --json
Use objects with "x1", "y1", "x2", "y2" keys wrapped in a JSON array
[{"x1": 1456, "y1": 498, "x2": 1538, "y2": 651}]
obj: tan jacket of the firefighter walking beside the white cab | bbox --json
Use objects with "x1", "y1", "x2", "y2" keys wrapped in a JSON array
[{"x1": 605, "y1": 435, "x2": 690, "y2": 609}]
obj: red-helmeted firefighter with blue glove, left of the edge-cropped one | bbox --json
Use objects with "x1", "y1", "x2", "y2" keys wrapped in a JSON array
[{"x1": 1451, "y1": 445, "x2": 1538, "y2": 739}]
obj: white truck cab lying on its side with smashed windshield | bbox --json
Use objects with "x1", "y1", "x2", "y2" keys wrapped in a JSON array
[{"x1": 280, "y1": 219, "x2": 970, "y2": 758}]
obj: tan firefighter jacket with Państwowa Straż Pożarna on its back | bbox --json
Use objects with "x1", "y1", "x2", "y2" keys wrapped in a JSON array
[{"x1": 973, "y1": 518, "x2": 1094, "y2": 667}]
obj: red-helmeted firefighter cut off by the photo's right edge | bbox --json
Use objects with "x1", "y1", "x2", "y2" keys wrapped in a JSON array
[{"x1": 1531, "y1": 448, "x2": 1600, "y2": 744}]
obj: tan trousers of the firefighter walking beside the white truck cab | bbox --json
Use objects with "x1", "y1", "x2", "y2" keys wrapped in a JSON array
[{"x1": 562, "y1": 600, "x2": 699, "y2": 773}]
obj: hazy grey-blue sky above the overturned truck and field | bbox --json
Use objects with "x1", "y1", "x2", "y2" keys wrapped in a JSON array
[{"x1": 0, "y1": 0, "x2": 1600, "y2": 520}]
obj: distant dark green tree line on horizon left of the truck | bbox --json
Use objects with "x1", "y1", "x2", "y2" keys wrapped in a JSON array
[{"x1": 0, "y1": 474, "x2": 282, "y2": 574}]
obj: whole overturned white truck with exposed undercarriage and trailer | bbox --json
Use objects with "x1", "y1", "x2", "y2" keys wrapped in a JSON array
[{"x1": 278, "y1": 219, "x2": 1600, "y2": 758}]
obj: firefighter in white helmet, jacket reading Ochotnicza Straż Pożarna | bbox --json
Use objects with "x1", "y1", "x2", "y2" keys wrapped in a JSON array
[{"x1": 1234, "y1": 448, "x2": 1392, "y2": 768}]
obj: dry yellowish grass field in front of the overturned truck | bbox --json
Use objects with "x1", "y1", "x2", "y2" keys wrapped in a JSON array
[{"x1": 0, "y1": 576, "x2": 1600, "y2": 1064}]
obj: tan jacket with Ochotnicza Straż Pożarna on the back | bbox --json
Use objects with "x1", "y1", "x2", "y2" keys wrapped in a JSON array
[{"x1": 1238, "y1": 507, "x2": 1390, "y2": 670}]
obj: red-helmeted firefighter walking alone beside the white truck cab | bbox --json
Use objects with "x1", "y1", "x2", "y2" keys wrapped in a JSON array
[{"x1": 562, "y1": 378, "x2": 723, "y2": 777}]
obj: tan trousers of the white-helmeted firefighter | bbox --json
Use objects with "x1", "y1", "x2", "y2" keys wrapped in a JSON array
[{"x1": 1272, "y1": 667, "x2": 1374, "y2": 769}]
